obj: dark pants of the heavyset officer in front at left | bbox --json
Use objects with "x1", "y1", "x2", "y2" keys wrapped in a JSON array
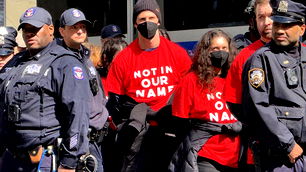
[{"x1": 0, "y1": 151, "x2": 52, "y2": 172}]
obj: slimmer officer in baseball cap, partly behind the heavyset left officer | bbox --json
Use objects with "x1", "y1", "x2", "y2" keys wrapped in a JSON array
[{"x1": 58, "y1": 8, "x2": 108, "y2": 172}]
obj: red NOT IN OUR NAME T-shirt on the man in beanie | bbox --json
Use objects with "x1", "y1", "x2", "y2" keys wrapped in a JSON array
[{"x1": 107, "y1": 37, "x2": 191, "y2": 111}]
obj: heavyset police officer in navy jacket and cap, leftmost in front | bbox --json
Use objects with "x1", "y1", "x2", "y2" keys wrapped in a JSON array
[{"x1": 0, "y1": 7, "x2": 91, "y2": 172}]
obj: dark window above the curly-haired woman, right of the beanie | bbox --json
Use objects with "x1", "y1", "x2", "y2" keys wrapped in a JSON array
[{"x1": 164, "y1": 0, "x2": 248, "y2": 31}]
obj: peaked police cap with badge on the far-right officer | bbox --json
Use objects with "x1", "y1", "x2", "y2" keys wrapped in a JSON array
[{"x1": 270, "y1": 0, "x2": 306, "y2": 23}]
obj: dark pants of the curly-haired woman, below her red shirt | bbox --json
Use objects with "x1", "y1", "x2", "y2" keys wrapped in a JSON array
[{"x1": 197, "y1": 156, "x2": 238, "y2": 172}]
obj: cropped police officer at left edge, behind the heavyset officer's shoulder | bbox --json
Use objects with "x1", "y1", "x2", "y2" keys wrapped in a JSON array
[{"x1": 0, "y1": 26, "x2": 17, "y2": 70}]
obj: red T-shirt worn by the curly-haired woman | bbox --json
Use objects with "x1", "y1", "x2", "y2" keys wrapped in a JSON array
[{"x1": 172, "y1": 72, "x2": 240, "y2": 168}]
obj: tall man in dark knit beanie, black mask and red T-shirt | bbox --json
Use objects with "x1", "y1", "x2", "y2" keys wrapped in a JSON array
[{"x1": 107, "y1": 0, "x2": 191, "y2": 171}]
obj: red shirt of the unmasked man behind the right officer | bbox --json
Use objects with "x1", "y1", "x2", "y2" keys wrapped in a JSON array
[{"x1": 224, "y1": 40, "x2": 264, "y2": 104}]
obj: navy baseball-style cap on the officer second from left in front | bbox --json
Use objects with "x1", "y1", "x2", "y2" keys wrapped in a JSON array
[{"x1": 60, "y1": 8, "x2": 91, "y2": 27}]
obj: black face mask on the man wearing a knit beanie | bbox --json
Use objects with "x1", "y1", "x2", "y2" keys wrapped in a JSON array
[{"x1": 137, "y1": 22, "x2": 158, "y2": 39}]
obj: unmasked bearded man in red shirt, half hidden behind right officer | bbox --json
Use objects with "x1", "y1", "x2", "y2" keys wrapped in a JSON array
[{"x1": 224, "y1": 0, "x2": 273, "y2": 168}]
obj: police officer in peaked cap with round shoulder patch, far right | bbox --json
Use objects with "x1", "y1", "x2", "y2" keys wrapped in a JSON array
[{"x1": 242, "y1": 0, "x2": 306, "y2": 171}]
